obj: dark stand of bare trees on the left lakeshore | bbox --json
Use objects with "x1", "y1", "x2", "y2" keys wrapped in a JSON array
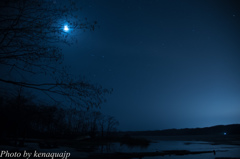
[{"x1": 0, "y1": 92, "x2": 118, "y2": 138}]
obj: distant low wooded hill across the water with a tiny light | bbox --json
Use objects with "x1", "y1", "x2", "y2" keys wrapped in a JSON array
[{"x1": 121, "y1": 124, "x2": 240, "y2": 136}]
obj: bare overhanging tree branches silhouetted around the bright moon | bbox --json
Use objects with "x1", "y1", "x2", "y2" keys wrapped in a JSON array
[{"x1": 0, "y1": 0, "x2": 111, "y2": 108}]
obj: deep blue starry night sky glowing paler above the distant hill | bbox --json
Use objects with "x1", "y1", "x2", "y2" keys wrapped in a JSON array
[{"x1": 63, "y1": 0, "x2": 240, "y2": 130}]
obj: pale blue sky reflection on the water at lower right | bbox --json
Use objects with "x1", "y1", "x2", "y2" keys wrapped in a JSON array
[{"x1": 97, "y1": 141, "x2": 240, "y2": 159}]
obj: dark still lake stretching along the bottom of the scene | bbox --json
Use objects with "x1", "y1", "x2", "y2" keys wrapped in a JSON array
[{"x1": 0, "y1": 138, "x2": 240, "y2": 159}]
